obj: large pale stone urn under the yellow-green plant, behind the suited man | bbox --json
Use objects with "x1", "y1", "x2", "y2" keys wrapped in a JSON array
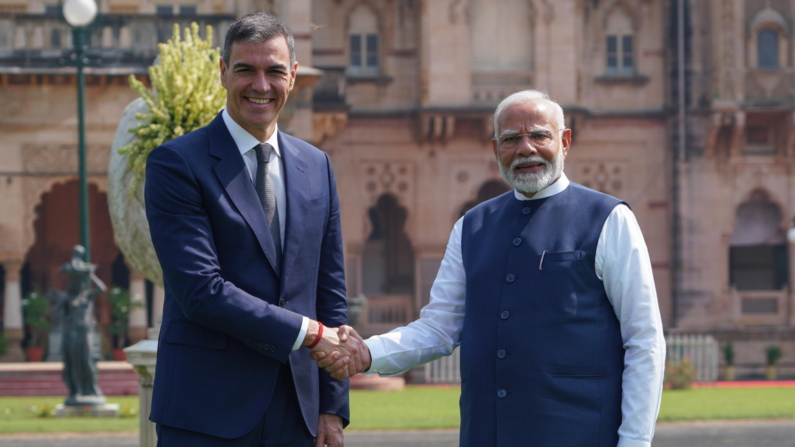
[{"x1": 108, "y1": 98, "x2": 163, "y2": 285}]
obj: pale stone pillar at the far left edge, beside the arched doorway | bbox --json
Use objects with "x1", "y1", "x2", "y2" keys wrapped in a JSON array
[{"x1": 2, "y1": 260, "x2": 25, "y2": 362}]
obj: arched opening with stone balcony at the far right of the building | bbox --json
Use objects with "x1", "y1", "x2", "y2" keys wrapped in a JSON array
[{"x1": 729, "y1": 189, "x2": 789, "y2": 290}]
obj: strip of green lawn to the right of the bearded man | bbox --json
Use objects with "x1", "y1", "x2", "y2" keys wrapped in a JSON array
[{"x1": 658, "y1": 388, "x2": 795, "y2": 421}]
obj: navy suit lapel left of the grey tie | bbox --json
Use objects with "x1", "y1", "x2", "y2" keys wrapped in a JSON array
[{"x1": 208, "y1": 113, "x2": 282, "y2": 275}]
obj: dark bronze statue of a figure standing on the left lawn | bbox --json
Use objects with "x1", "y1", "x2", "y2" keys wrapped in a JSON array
[{"x1": 55, "y1": 245, "x2": 106, "y2": 406}]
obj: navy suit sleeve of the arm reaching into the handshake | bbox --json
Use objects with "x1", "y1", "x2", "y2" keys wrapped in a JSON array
[{"x1": 145, "y1": 145, "x2": 302, "y2": 363}]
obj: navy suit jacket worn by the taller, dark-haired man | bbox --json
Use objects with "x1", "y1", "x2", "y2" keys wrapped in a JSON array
[{"x1": 145, "y1": 114, "x2": 349, "y2": 438}]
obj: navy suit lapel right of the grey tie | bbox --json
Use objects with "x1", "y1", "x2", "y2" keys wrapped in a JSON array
[{"x1": 278, "y1": 132, "x2": 310, "y2": 290}]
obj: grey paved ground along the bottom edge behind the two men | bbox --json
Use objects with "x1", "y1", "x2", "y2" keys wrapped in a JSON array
[{"x1": 0, "y1": 420, "x2": 795, "y2": 447}]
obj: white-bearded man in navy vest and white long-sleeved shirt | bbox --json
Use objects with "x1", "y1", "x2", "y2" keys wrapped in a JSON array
[{"x1": 313, "y1": 90, "x2": 665, "y2": 447}]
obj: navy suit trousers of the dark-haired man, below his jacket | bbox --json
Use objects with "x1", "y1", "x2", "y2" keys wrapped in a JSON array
[{"x1": 155, "y1": 363, "x2": 315, "y2": 447}]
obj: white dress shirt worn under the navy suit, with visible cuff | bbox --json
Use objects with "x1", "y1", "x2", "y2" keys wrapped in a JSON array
[{"x1": 222, "y1": 109, "x2": 309, "y2": 351}]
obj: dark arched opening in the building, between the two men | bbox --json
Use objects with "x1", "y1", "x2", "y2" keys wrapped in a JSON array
[{"x1": 361, "y1": 193, "x2": 415, "y2": 295}]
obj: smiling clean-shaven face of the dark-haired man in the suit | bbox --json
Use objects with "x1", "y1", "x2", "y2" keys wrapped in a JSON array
[{"x1": 221, "y1": 36, "x2": 298, "y2": 142}]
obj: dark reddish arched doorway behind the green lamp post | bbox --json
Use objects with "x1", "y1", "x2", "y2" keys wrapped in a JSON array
[{"x1": 21, "y1": 180, "x2": 119, "y2": 358}]
